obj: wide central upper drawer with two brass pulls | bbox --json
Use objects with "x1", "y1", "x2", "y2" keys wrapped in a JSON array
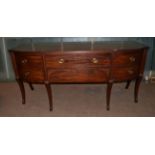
[{"x1": 45, "y1": 52, "x2": 110, "y2": 68}]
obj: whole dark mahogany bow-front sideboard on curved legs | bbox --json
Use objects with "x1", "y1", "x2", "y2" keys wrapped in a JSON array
[{"x1": 9, "y1": 41, "x2": 148, "y2": 111}]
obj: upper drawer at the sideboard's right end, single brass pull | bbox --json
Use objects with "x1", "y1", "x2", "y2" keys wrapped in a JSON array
[{"x1": 113, "y1": 52, "x2": 142, "y2": 66}]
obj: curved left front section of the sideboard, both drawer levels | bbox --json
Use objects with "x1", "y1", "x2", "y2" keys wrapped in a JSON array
[{"x1": 15, "y1": 52, "x2": 45, "y2": 82}]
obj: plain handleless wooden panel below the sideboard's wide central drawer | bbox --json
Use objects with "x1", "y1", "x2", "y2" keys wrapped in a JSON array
[{"x1": 47, "y1": 68, "x2": 109, "y2": 83}]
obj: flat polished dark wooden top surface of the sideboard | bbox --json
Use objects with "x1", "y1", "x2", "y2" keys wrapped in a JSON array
[{"x1": 9, "y1": 41, "x2": 148, "y2": 52}]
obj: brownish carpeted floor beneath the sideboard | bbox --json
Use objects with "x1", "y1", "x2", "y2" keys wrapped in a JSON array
[{"x1": 0, "y1": 82, "x2": 155, "y2": 117}]
